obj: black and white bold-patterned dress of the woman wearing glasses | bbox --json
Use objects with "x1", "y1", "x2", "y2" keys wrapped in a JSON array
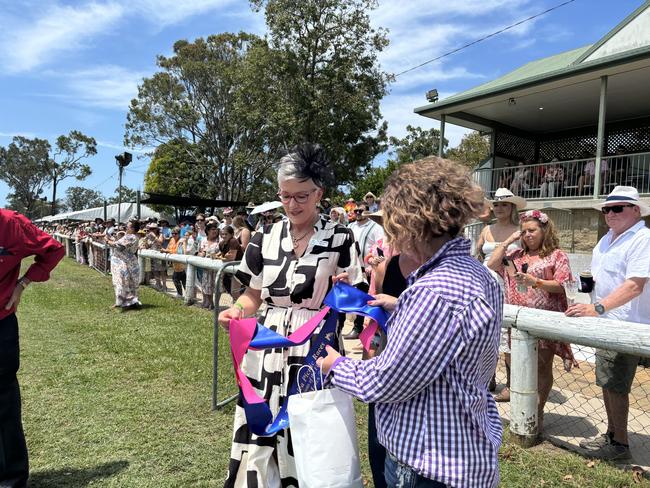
[{"x1": 225, "y1": 219, "x2": 363, "y2": 488}]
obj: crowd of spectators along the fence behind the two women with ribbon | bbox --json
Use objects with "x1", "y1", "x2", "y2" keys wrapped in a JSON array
[{"x1": 42, "y1": 192, "x2": 383, "y2": 308}]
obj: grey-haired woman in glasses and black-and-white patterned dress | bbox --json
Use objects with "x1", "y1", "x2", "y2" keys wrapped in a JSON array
[{"x1": 219, "y1": 144, "x2": 363, "y2": 488}]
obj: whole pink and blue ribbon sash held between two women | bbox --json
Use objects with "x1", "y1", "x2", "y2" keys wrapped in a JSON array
[{"x1": 230, "y1": 282, "x2": 388, "y2": 436}]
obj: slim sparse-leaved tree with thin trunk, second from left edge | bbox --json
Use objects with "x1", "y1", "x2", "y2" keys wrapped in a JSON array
[{"x1": 48, "y1": 130, "x2": 97, "y2": 215}]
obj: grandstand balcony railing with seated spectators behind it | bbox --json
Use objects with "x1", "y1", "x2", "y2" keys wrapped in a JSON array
[{"x1": 474, "y1": 153, "x2": 650, "y2": 200}]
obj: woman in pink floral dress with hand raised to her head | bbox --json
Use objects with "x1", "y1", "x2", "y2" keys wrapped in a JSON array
[{"x1": 487, "y1": 210, "x2": 577, "y2": 432}]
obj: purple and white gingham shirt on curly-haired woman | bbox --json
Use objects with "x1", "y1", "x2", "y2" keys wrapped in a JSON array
[{"x1": 330, "y1": 237, "x2": 503, "y2": 487}]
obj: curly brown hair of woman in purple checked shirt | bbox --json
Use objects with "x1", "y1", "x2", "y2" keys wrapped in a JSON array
[{"x1": 382, "y1": 156, "x2": 484, "y2": 254}]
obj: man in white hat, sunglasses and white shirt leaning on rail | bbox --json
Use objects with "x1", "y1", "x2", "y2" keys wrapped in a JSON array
[{"x1": 566, "y1": 186, "x2": 650, "y2": 461}]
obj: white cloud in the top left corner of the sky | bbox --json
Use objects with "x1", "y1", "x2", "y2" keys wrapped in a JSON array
[{"x1": 0, "y1": 2, "x2": 123, "y2": 73}]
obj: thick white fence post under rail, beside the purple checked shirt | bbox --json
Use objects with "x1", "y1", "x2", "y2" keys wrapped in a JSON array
[{"x1": 510, "y1": 328, "x2": 539, "y2": 447}]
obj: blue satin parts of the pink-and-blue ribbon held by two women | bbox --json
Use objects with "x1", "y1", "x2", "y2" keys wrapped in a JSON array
[{"x1": 240, "y1": 282, "x2": 388, "y2": 436}]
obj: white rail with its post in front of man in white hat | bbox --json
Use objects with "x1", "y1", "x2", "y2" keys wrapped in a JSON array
[{"x1": 503, "y1": 305, "x2": 650, "y2": 446}]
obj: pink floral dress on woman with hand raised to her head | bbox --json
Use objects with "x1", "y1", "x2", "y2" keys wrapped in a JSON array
[{"x1": 501, "y1": 249, "x2": 577, "y2": 365}]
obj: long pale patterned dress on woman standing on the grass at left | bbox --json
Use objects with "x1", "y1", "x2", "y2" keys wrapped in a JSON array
[{"x1": 111, "y1": 234, "x2": 140, "y2": 307}]
